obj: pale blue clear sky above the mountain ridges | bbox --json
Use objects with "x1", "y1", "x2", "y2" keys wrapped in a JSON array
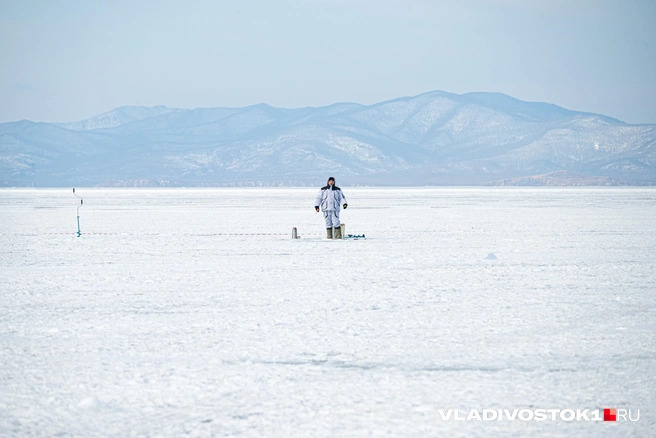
[{"x1": 0, "y1": 0, "x2": 656, "y2": 123}]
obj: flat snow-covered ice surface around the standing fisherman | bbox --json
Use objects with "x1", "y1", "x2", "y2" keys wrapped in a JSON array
[{"x1": 0, "y1": 188, "x2": 656, "y2": 437}]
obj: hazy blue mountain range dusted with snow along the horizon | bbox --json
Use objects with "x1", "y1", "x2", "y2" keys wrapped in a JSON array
[{"x1": 0, "y1": 91, "x2": 656, "y2": 187}]
